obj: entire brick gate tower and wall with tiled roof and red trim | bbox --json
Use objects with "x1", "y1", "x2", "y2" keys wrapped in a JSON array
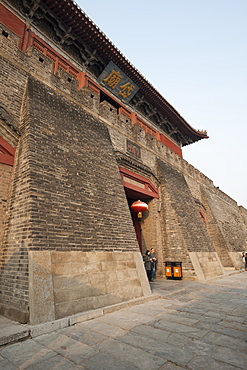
[{"x1": 0, "y1": 0, "x2": 247, "y2": 324}]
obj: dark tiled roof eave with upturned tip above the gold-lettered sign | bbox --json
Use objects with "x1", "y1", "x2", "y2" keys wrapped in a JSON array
[{"x1": 43, "y1": 0, "x2": 208, "y2": 142}]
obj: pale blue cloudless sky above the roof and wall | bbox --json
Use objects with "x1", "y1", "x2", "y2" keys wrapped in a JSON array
[{"x1": 77, "y1": 0, "x2": 247, "y2": 208}]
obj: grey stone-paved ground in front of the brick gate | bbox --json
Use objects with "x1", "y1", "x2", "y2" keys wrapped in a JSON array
[{"x1": 0, "y1": 272, "x2": 247, "y2": 370}]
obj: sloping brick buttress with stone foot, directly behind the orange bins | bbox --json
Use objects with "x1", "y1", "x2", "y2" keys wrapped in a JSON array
[{"x1": 158, "y1": 160, "x2": 228, "y2": 279}]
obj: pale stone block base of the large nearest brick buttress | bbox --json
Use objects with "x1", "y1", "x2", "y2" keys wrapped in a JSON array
[{"x1": 29, "y1": 251, "x2": 151, "y2": 325}]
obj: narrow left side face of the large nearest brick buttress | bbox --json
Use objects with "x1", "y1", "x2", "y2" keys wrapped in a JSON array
[{"x1": 0, "y1": 129, "x2": 31, "y2": 311}]
